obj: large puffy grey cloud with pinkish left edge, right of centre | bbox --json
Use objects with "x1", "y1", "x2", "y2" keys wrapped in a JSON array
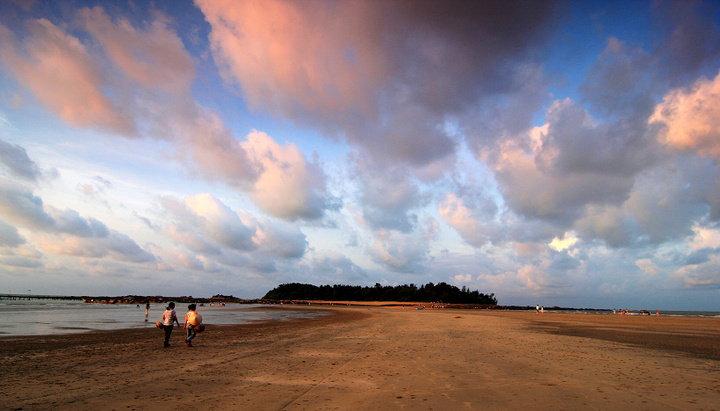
[{"x1": 480, "y1": 90, "x2": 658, "y2": 231}]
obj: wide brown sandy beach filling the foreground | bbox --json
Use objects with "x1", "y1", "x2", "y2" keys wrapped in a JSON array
[{"x1": 0, "y1": 307, "x2": 720, "y2": 410}]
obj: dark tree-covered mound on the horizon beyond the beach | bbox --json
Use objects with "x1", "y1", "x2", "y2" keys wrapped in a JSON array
[{"x1": 263, "y1": 282, "x2": 497, "y2": 305}]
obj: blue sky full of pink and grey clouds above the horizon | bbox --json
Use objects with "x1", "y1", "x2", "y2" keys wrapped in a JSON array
[{"x1": 0, "y1": 0, "x2": 720, "y2": 311}]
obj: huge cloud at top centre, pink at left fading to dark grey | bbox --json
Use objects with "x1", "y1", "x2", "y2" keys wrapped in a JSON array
[{"x1": 196, "y1": 0, "x2": 554, "y2": 166}]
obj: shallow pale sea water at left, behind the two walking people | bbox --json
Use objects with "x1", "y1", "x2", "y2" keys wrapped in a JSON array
[{"x1": 0, "y1": 299, "x2": 327, "y2": 336}]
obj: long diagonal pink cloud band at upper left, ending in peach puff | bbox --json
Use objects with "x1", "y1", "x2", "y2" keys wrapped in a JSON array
[{"x1": 0, "y1": 7, "x2": 337, "y2": 221}]
